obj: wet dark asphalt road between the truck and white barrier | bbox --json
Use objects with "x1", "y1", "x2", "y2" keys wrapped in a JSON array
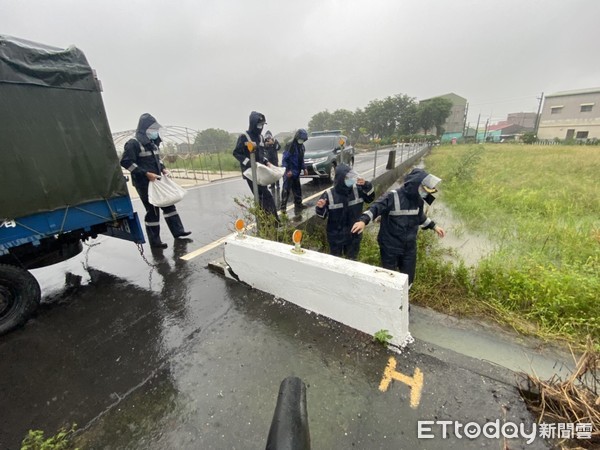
[{"x1": 0, "y1": 155, "x2": 546, "y2": 449}]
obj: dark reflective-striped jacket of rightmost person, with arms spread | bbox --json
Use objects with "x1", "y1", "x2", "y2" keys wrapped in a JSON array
[{"x1": 360, "y1": 169, "x2": 435, "y2": 253}]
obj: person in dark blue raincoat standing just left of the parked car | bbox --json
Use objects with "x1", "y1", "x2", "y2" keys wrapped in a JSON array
[{"x1": 280, "y1": 128, "x2": 308, "y2": 214}]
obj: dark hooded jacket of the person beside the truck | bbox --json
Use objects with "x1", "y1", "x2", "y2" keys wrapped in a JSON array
[{"x1": 121, "y1": 113, "x2": 165, "y2": 190}]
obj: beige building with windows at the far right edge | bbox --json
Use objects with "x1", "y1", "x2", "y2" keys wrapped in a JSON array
[{"x1": 537, "y1": 88, "x2": 600, "y2": 140}]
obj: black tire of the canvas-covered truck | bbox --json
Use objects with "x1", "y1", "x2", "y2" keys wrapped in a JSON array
[{"x1": 0, "y1": 264, "x2": 42, "y2": 335}]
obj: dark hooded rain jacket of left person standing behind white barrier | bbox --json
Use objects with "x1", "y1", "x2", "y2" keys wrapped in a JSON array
[{"x1": 316, "y1": 164, "x2": 375, "y2": 244}]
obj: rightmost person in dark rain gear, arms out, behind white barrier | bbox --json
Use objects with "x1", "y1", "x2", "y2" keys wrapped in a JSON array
[{"x1": 352, "y1": 169, "x2": 446, "y2": 285}]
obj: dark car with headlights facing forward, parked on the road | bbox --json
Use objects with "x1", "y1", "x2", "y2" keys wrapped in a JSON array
[{"x1": 302, "y1": 131, "x2": 354, "y2": 181}]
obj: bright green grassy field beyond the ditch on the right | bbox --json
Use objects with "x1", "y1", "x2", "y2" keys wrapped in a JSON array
[{"x1": 415, "y1": 144, "x2": 600, "y2": 343}]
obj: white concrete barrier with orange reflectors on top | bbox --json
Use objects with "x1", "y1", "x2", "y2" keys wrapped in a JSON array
[{"x1": 224, "y1": 235, "x2": 412, "y2": 348}]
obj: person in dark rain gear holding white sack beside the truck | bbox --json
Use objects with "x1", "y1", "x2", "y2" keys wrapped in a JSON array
[{"x1": 121, "y1": 113, "x2": 191, "y2": 248}]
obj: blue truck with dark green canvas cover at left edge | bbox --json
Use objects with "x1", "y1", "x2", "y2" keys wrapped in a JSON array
[{"x1": 0, "y1": 35, "x2": 144, "y2": 334}]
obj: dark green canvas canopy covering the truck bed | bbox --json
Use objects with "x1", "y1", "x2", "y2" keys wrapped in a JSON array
[{"x1": 0, "y1": 35, "x2": 127, "y2": 220}]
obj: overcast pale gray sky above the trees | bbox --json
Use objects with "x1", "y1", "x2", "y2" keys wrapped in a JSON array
[{"x1": 0, "y1": 0, "x2": 600, "y2": 133}]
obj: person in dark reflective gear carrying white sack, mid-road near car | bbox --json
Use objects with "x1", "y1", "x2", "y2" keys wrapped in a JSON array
[{"x1": 233, "y1": 111, "x2": 279, "y2": 222}]
